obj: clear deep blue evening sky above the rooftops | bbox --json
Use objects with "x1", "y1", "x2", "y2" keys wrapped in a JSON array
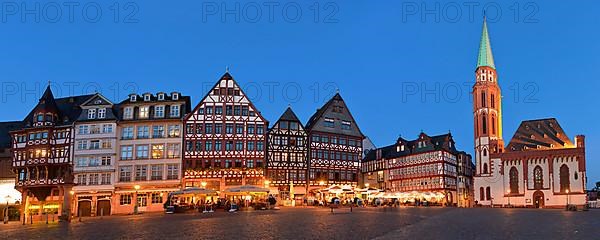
[{"x1": 0, "y1": 0, "x2": 600, "y2": 186}]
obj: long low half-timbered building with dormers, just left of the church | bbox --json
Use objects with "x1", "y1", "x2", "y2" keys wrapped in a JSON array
[{"x1": 362, "y1": 133, "x2": 473, "y2": 206}]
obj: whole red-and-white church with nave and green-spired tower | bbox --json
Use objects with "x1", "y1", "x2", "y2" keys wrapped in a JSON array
[{"x1": 473, "y1": 17, "x2": 586, "y2": 208}]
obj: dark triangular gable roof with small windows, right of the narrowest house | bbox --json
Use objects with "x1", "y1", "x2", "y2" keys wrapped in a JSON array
[{"x1": 306, "y1": 92, "x2": 364, "y2": 138}]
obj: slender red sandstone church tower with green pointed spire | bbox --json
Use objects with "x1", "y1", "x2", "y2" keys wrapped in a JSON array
[{"x1": 473, "y1": 17, "x2": 504, "y2": 177}]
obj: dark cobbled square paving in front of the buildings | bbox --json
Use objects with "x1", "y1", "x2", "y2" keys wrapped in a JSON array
[{"x1": 0, "y1": 208, "x2": 600, "y2": 240}]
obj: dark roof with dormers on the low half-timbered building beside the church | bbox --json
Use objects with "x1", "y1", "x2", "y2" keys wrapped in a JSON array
[{"x1": 363, "y1": 132, "x2": 460, "y2": 162}]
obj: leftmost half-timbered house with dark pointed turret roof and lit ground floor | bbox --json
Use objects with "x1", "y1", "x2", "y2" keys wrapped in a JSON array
[{"x1": 11, "y1": 86, "x2": 91, "y2": 220}]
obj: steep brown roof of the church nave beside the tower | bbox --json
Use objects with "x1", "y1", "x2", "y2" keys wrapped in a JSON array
[{"x1": 505, "y1": 118, "x2": 574, "y2": 152}]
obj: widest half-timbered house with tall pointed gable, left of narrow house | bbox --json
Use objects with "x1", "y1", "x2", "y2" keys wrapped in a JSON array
[{"x1": 183, "y1": 72, "x2": 268, "y2": 191}]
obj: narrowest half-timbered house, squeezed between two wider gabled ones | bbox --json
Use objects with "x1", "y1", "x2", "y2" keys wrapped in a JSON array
[{"x1": 267, "y1": 107, "x2": 308, "y2": 199}]
